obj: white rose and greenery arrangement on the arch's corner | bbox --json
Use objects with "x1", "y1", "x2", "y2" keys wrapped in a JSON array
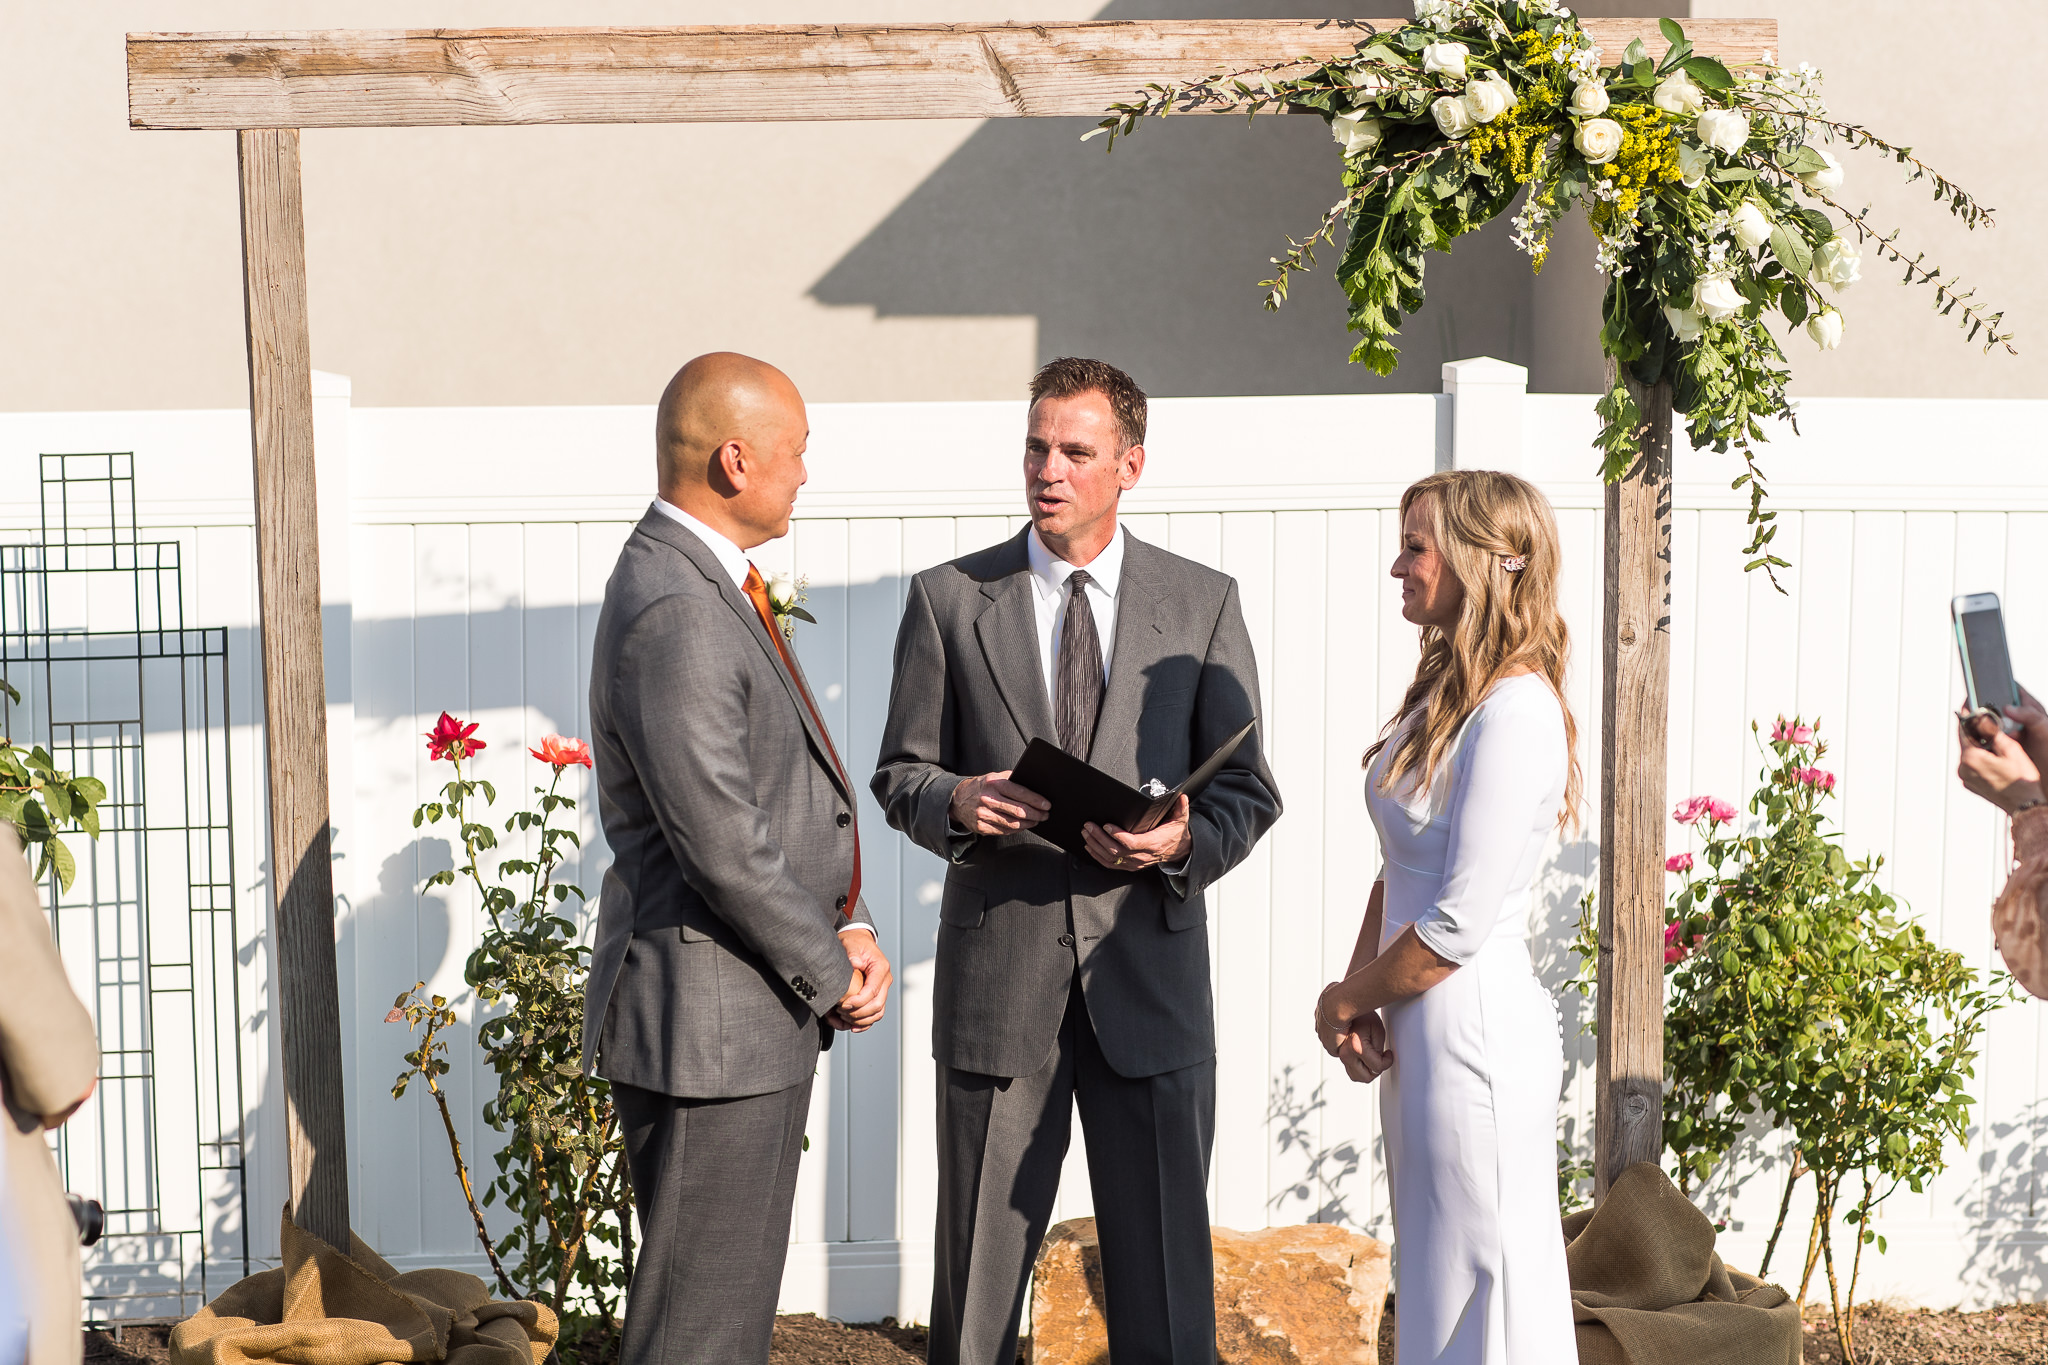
[{"x1": 1085, "y1": 0, "x2": 2017, "y2": 569}]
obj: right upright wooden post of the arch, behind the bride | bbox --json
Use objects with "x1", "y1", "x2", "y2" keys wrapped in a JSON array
[{"x1": 1593, "y1": 360, "x2": 1671, "y2": 1199}]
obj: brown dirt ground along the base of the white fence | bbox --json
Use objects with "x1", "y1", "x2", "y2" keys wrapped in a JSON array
[{"x1": 86, "y1": 1304, "x2": 2048, "y2": 1365}]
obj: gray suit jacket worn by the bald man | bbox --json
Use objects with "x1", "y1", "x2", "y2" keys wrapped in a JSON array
[{"x1": 584, "y1": 510, "x2": 870, "y2": 1097}]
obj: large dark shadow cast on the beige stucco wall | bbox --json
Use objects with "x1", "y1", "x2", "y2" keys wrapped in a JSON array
[{"x1": 811, "y1": 0, "x2": 1646, "y2": 397}]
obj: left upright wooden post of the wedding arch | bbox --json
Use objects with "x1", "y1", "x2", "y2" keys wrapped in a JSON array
[{"x1": 238, "y1": 129, "x2": 348, "y2": 1246}]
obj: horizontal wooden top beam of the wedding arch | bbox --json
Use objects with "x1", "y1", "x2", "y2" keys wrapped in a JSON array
[{"x1": 127, "y1": 18, "x2": 1778, "y2": 129}]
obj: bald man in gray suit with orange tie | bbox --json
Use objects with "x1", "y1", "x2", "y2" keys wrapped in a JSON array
[{"x1": 584, "y1": 354, "x2": 889, "y2": 1365}]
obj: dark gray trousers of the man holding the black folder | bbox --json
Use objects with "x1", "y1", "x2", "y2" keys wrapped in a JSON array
[{"x1": 930, "y1": 980, "x2": 1217, "y2": 1365}]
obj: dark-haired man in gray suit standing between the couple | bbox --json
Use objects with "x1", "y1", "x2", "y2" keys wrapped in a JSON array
[{"x1": 872, "y1": 358, "x2": 1280, "y2": 1365}]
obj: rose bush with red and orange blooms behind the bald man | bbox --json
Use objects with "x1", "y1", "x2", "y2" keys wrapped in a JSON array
[{"x1": 387, "y1": 714, "x2": 633, "y2": 1345}]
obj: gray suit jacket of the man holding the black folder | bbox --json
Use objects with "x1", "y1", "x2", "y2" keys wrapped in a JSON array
[{"x1": 872, "y1": 528, "x2": 1280, "y2": 1076}]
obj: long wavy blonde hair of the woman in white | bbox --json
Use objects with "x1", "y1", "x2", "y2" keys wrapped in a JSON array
[{"x1": 1364, "y1": 469, "x2": 1581, "y2": 829}]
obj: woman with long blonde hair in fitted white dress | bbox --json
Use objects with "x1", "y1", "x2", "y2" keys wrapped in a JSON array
[{"x1": 1315, "y1": 471, "x2": 1579, "y2": 1365}]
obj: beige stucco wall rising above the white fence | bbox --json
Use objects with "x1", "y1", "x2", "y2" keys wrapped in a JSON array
[{"x1": 0, "y1": 0, "x2": 2048, "y2": 411}]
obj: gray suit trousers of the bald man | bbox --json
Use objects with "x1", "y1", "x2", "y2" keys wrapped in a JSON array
[{"x1": 612, "y1": 1076, "x2": 813, "y2": 1365}]
